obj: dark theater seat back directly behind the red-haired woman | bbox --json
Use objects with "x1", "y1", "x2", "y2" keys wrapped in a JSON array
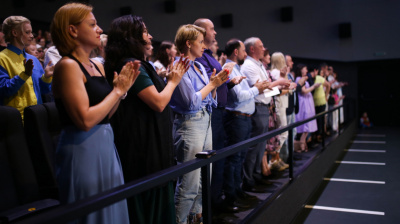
[{"x1": 24, "y1": 102, "x2": 61, "y2": 199}]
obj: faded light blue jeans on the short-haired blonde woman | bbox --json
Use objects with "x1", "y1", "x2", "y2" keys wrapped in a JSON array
[{"x1": 174, "y1": 109, "x2": 212, "y2": 223}]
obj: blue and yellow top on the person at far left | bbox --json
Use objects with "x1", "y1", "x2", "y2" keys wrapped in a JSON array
[{"x1": 0, "y1": 44, "x2": 53, "y2": 119}]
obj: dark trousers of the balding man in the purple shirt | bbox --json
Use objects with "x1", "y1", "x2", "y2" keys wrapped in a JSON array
[{"x1": 211, "y1": 108, "x2": 225, "y2": 206}]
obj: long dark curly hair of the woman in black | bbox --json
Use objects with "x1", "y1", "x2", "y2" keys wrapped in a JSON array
[{"x1": 104, "y1": 15, "x2": 147, "y2": 84}]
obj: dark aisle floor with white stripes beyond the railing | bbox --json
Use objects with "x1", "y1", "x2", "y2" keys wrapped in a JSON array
[{"x1": 293, "y1": 128, "x2": 400, "y2": 224}]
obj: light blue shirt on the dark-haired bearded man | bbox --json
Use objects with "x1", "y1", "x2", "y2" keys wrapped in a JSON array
[{"x1": 223, "y1": 59, "x2": 259, "y2": 114}]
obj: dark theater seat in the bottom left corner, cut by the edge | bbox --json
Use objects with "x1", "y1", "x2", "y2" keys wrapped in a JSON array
[{"x1": 0, "y1": 106, "x2": 58, "y2": 222}]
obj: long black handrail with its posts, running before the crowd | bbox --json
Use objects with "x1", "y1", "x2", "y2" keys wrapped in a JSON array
[{"x1": 15, "y1": 105, "x2": 350, "y2": 224}]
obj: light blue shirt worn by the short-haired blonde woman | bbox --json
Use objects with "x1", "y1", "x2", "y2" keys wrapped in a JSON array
[{"x1": 170, "y1": 58, "x2": 217, "y2": 114}]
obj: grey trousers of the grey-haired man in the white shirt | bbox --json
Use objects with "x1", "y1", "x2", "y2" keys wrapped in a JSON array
[{"x1": 243, "y1": 105, "x2": 269, "y2": 187}]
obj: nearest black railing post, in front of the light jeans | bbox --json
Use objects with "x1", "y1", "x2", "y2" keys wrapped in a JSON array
[{"x1": 201, "y1": 164, "x2": 212, "y2": 224}]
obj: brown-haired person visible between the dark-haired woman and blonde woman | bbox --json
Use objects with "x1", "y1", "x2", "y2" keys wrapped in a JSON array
[{"x1": 154, "y1": 41, "x2": 176, "y2": 79}]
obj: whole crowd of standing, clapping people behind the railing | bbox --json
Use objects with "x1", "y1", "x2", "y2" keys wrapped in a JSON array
[{"x1": 0, "y1": 3, "x2": 347, "y2": 224}]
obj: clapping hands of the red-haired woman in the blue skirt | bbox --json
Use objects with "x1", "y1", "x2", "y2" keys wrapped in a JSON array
[{"x1": 113, "y1": 60, "x2": 140, "y2": 96}]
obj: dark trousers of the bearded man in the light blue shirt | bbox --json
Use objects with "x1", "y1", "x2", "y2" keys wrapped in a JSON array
[{"x1": 224, "y1": 112, "x2": 251, "y2": 204}]
